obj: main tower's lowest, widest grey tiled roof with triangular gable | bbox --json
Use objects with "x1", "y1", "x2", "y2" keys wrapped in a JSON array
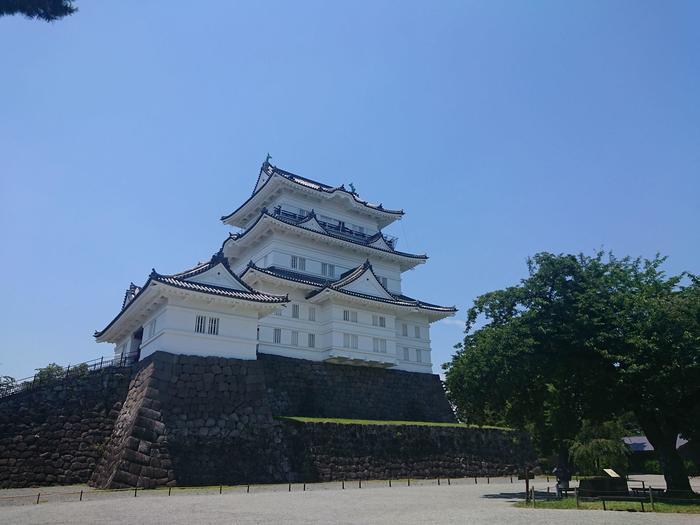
[{"x1": 241, "y1": 261, "x2": 457, "y2": 313}]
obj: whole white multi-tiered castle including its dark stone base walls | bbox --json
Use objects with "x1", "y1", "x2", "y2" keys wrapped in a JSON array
[{"x1": 0, "y1": 162, "x2": 532, "y2": 488}]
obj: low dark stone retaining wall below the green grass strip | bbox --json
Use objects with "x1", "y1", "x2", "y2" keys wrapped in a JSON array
[{"x1": 284, "y1": 421, "x2": 534, "y2": 481}]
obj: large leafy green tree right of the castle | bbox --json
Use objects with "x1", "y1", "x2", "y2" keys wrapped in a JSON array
[{"x1": 445, "y1": 253, "x2": 700, "y2": 491}]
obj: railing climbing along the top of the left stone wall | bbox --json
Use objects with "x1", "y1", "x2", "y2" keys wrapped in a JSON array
[{"x1": 0, "y1": 351, "x2": 139, "y2": 398}]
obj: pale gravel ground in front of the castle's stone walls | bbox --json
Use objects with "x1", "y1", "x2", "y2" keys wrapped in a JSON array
[{"x1": 0, "y1": 476, "x2": 700, "y2": 525}]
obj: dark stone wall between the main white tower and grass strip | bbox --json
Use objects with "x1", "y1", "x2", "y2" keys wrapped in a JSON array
[{"x1": 258, "y1": 354, "x2": 455, "y2": 422}]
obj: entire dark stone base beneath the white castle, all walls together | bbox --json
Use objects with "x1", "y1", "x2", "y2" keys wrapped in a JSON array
[{"x1": 0, "y1": 352, "x2": 531, "y2": 488}]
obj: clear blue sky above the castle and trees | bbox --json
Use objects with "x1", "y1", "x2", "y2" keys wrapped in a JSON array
[{"x1": 0, "y1": 0, "x2": 700, "y2": 377}]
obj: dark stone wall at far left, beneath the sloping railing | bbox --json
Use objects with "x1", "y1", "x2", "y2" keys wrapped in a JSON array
[{"x1": 0, "y1": 368, "x2": 130, "y2": 488}]
